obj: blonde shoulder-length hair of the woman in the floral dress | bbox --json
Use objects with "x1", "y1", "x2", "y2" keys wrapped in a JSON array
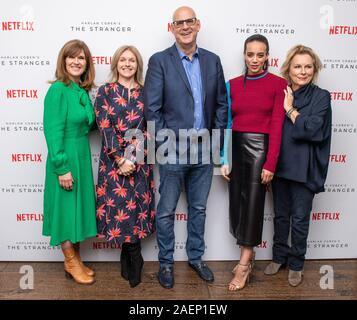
[{"x1": 109, "y1": 45, "x2": 144, "y2": 86}]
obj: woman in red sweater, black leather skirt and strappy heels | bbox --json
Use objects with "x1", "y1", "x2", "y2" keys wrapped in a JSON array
[{"x1": 221, "y1": 34, "x2": 287, "y2": 291}]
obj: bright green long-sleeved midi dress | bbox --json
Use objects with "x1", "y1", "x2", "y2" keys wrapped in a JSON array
[{"x1": 42, "y1": 81, "x2": 97, "y2": 246}]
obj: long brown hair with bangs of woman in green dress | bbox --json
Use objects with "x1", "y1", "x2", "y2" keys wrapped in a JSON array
[{"x1": 53, "y1": 39, "x2": 95, "y2": 91}]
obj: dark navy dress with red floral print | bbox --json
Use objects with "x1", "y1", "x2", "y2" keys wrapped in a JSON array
[{"x1": 94, "y1": 82, "x2": 155, "y2": 245}]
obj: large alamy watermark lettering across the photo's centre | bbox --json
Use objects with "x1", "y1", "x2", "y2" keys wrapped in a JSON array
[{"x1": 119, "y1": 121, "x2": 231, "y2": 172}]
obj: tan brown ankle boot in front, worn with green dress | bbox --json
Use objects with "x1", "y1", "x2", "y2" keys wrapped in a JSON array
[{"x1": 62, "y1": 247, "x2": 95, "y2": 284}]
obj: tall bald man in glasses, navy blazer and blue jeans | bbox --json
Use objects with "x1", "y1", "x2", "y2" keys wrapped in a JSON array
[{"x1": 144, "y1": 7, "x2": 228, "y2": 288}]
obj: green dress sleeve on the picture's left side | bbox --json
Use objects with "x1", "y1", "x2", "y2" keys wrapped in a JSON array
[{"x1": 43, "y1": 83, "x2": 71, "y2": 176}]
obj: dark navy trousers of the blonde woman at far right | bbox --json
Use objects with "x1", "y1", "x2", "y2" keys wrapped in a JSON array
[{"x1": 272, "y1": 177, "x2": 315, "y2": 271}]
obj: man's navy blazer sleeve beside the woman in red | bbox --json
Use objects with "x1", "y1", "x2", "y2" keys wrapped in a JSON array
[{"x1": 215, "y1": 57, "x2": 228, "y2": 151}]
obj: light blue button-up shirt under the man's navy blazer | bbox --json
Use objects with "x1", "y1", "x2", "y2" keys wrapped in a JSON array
[{"x1": 176, "y1": 46, "x2": 206, "y2": 130}]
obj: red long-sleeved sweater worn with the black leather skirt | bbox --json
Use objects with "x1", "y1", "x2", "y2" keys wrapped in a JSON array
[{"x1": 229, "y1": 73, "x2": 287, "y2": 172}]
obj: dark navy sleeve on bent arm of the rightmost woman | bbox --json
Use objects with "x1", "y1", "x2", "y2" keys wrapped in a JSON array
[{"x1": 292, "y1": 91, "x2": 331, "y2": 142}]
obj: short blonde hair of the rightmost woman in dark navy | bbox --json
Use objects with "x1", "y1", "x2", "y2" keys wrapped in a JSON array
[{"x1": 280, "y1": 44, "x2": 322, "y2": 83}]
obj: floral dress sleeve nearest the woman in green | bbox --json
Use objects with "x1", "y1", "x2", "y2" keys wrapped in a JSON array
[{"x1": 94, "y1": 85, "x2": 124, "y2": 160}]
